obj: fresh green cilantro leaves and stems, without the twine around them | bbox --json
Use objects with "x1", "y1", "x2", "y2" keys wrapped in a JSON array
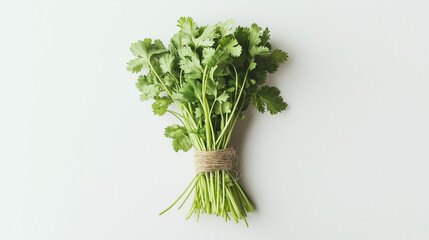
[{"x1": 127, "y1": 17, "x2": 288, "y2": 225}]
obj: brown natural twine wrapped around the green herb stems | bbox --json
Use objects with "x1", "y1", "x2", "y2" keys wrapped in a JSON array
[{"x1": 195, "y1": 148, "x2": 238, "y2": 174}]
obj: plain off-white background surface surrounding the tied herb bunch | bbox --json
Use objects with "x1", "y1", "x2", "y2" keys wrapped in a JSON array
[{"x1": 0, "y1": 0, "x2": 429, "y2": 240}]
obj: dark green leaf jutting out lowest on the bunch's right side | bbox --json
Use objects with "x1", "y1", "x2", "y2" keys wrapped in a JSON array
[{"x1": 252, "y1": 86, "x2": 287, "y2": 114}]
